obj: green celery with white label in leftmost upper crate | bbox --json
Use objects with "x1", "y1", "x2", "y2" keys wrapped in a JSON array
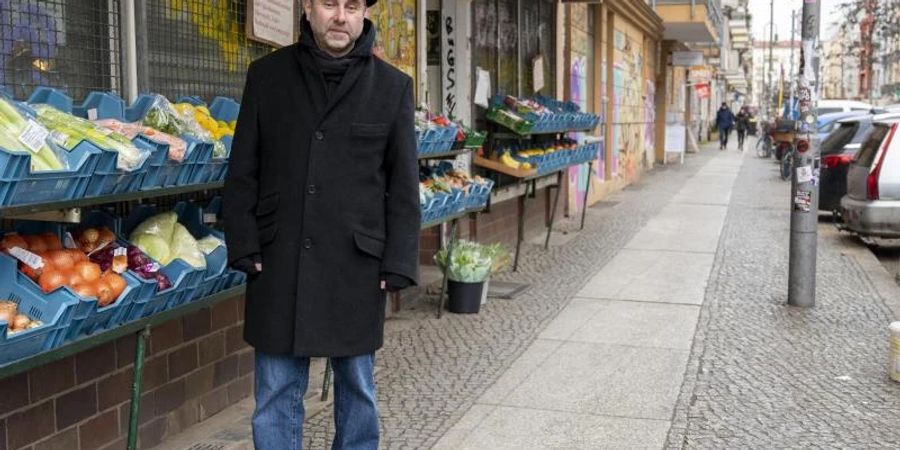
[{"x1": 0, "y1": 95, "x2": 68, "y2": 172}]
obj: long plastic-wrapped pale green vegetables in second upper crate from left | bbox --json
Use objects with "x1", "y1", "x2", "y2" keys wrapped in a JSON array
[{"x1": 33, "y1": 105, "x2": 150, "y2": 172}]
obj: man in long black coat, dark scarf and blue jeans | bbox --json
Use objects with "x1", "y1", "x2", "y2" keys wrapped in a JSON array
[{"x1": 223, "y1": 0, "x2": 420, "y2": 449}]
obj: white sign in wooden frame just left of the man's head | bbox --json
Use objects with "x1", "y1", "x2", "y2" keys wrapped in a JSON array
[{"x1": 247, "y1": 0, "x2": 297, "y2": 47}]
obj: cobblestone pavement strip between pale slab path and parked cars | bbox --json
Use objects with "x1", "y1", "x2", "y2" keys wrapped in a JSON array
[{"x1": 667, "y1": 150, "x2": 900, "y2": 448}]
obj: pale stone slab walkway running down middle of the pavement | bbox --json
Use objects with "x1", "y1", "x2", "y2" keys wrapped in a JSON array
[{"x1": 436, "y1": 150, "x2": 743, "y2": 450}]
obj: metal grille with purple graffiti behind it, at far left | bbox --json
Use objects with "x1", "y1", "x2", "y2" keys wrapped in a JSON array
[{"x1": 0, "y1": 0, "x2": 121, "y2": 100}]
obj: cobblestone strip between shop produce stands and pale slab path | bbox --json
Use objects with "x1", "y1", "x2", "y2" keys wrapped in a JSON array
[{"x1": 304, "y1": 151, "x2": 715, "y2": 450}]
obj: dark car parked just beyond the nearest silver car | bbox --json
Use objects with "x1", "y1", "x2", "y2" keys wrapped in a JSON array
[{"x1": 819, "y1": 113, "x2": 900, "y2": 211}]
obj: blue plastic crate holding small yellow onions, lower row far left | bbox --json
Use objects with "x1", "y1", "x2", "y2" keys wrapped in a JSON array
[{"x1": 0, "y1": 254, "x2": 79, "y2": 365}]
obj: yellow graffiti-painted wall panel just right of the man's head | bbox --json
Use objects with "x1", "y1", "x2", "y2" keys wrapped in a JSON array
[{"x1": 368, "y1": 0, "x2": 416, "y2": 82}]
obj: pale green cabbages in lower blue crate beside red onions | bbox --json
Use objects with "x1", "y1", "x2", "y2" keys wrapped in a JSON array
[{"x1": 131, "y1": 212, "x2": 206, "y2": 269}]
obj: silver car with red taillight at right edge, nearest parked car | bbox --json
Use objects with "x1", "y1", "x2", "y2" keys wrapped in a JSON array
[{"x1": 840, "y1": 119, "x2": 900, "y2": 238}]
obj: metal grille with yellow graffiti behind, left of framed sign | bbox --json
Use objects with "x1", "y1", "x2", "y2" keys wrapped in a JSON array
[{"x1": 146, "y1": 0, "x2": 278, "y2": 101}]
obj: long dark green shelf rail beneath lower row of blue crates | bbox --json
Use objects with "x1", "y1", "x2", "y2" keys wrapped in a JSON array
[{"x1": 0, "y1": 285, "x2": 246, "y2": 379}]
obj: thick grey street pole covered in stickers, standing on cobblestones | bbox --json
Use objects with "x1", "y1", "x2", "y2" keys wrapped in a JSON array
[{"x1": 788, "y1": 0, "x2": 820, "y2": 307}]
